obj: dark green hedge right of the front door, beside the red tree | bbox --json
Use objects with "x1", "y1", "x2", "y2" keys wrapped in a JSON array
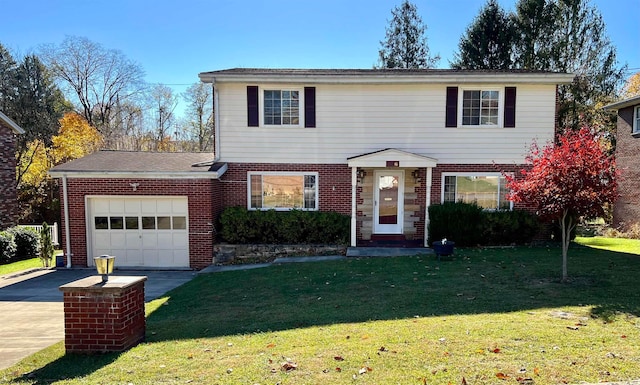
[{"x1": 429, "y1": 202, "x2": 540, "y2": 246}]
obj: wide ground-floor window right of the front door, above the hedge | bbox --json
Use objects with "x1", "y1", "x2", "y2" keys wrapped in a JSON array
[{"x1": 442, "y1": 173, "x2": 513, "y2": 210}]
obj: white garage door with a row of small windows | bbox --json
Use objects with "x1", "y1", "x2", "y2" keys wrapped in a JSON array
[{"x1": 87, "y1": 197, "x2": 189, "y2": 267}]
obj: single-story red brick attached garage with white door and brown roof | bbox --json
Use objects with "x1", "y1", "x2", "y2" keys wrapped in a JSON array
[{"x1": 50, "y1": 151, "x2": 227, "y2": 269}]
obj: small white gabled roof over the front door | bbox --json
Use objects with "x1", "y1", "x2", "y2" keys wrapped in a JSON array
[{"x1": 347, "y1": 148, "x2": 438, "y2": 167}]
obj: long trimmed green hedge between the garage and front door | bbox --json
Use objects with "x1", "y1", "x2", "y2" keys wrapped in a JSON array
[{"x1": 220, "y1": 207, "x2": 350, "y2": 245}]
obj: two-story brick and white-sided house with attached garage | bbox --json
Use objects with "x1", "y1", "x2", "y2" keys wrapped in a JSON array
[{"x1": 52, "y1": 69, "x2": 573, "y2": 268}]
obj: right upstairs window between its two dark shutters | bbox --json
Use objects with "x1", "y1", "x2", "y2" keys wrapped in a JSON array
[{"x1": 462, "y1": 89, "x2": 500, "y2": 126}]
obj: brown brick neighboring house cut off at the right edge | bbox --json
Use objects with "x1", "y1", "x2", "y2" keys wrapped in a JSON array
[{"x1": 604, "y1": 95, "x2": 640, "y2": 231}]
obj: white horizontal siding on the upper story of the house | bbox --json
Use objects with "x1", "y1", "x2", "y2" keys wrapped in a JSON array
[{"x1": 216, "y1": 83, "x2": 555, "y2": 164}]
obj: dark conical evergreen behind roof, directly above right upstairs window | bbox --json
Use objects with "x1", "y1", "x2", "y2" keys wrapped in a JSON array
[{"x1": 451, "y1": 0, "x2": 515, "y2": 69}]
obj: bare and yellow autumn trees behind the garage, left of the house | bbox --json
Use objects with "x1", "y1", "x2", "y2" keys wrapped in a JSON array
[{"x1": 0, "y1": 36, "x2": 214, "y2": 223}]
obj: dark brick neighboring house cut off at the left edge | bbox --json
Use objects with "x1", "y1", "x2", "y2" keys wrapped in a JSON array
[{"x1": 0, "y1": 111, "x2": 24, "y2": 230}]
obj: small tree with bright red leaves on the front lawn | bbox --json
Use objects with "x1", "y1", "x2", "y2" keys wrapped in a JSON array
[{"x1": 506, "y1": 127, "x2": 617, "y2": 281}]
